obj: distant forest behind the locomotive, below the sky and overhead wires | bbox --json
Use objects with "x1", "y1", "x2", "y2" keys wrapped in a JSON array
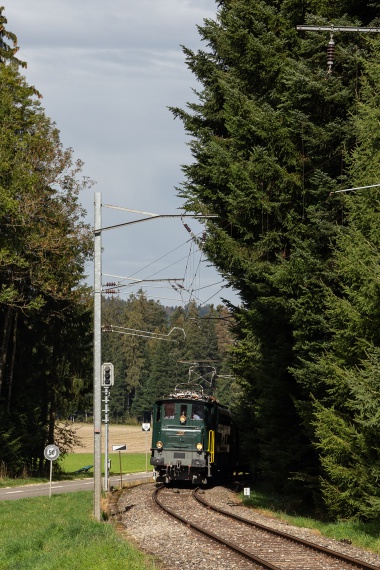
[{"x1": 102, "y1": 292, "x2": 236, "y2": 422}]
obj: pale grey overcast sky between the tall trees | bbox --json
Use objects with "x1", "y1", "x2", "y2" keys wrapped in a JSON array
[{"x1": 3, "y1": 0, "x2": 236, "y2": 305}]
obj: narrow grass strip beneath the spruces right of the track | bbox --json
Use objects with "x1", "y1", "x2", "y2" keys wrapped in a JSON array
[{"x1": 242, "y1": 489, "x2": 380, "y2": 555}]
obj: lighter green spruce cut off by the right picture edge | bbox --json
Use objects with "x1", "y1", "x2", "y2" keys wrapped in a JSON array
[{"x1": 314, "y1": 34, "x2": 380, "y2": 519}]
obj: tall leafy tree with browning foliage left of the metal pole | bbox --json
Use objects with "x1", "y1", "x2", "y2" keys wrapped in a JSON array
[{"x1": 0, "y1": 13, "x2": 92, "y2": 467}]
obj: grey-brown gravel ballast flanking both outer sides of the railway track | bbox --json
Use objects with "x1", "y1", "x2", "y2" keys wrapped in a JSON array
[{"x1": 117, "y1": 483, "x2": 380, "y2": 570}]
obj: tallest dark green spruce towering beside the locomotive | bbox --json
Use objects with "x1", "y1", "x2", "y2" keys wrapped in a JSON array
[{"x1": 172, "y1": 0, "x2": 379, "y2": 506}]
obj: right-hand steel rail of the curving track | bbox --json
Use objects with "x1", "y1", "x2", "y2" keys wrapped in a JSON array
[{"x1": 193, "y1": 487, "x2": 379, "y2": 570}]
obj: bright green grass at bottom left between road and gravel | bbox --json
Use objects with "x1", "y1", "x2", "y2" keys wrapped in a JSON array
[{"x1": 0, "y1": 491, "x2": 157, "y2": 570}]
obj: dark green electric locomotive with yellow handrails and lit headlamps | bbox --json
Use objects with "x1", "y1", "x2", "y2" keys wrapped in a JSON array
[{"x1": 150, "y1": 384, "x2": 238, "y2": 484}]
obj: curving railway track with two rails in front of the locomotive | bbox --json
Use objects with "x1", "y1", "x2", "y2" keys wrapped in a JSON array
[{"x1": 153, "y1": 487, "x2": 379, "y2": 570}]
